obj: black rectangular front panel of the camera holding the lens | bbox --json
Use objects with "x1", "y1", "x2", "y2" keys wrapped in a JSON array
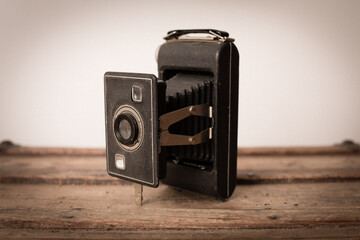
[{"x1": 104, "y1": 72, "x2": 159, "y2": 187}]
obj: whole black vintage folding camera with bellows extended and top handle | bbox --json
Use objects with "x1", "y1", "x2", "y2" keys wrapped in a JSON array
[{"x1": 104, "y1": 29, "x2": 239, "y2": 202}]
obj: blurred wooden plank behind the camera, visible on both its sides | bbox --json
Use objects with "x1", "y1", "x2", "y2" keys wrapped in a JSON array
[{"x1": 0, "y1": 154, "x2": 360, "y2": 184}]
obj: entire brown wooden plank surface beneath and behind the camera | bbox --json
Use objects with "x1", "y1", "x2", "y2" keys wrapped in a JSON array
[{"x1": 0, "y1": 143, "x2": 360, "y2": 239}]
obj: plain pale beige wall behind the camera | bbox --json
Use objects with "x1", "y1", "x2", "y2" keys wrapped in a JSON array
[{"x1": 0, "y1": 0, "x2": 360, "y2": 147}]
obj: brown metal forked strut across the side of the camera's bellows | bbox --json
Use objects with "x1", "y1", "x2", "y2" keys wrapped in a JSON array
[{"x1": 159, "y1": 104, "x2": 212, "y2": 146}]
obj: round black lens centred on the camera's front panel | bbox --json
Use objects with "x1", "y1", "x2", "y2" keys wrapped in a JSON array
[{"x1": 114, "y1": 112, "x2": 139, "y2": 146}]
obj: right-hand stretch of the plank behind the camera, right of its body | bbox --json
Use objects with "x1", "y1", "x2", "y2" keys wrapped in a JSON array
[{"x1": 237, "y1": 154, "x2": 360, "y2": 183}]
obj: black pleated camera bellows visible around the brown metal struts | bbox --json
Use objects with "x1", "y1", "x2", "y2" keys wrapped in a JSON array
[{"x1": 166, "y1": 72, "x2": 213, "y2": 169}]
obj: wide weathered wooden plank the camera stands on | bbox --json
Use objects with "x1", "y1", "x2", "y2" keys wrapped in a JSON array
[{"x1": 0, "y1": 182, "x2": 360, "y2": 231}]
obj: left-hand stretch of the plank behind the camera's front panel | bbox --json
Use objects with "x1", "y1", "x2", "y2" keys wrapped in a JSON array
[{"x1": 0, "y1": 155, "x2": 118, "y2": 184}]
